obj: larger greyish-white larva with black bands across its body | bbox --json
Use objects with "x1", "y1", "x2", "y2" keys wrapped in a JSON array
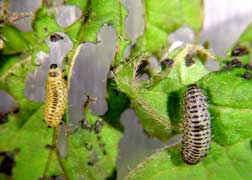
[{"x1": 182, "y1": 85, "x2": 211, "y2": 164}]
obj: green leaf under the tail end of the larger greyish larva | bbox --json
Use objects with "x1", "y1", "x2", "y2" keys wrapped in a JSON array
[{"x1": 125, "y1": 139, "x2": 252, "y2": 180}]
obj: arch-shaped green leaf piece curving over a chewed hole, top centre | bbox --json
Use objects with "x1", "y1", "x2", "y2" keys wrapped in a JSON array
[{"x1": 80, "y1": 0, "x2": 129, "y2": 64}]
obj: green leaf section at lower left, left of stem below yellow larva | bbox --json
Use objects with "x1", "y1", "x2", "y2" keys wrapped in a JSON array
[{"x1": 0, "y1": 108, "x2": 53, "y2": 179}]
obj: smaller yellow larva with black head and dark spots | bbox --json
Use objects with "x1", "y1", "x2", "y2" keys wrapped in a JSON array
[{"x1": 45, "y1": 64, "x2": 67, "y2": 127}]
